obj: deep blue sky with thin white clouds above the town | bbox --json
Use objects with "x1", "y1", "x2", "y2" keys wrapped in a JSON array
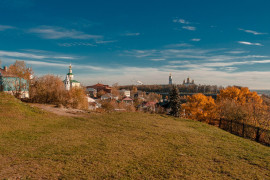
[{"x1": 0, "y1": 0, "x2": 270, "y2": 89}]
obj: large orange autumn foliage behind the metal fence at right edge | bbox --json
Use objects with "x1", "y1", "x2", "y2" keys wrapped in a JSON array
[{"x1": 217, "y1": 87, "x2": 270, "y2": 141}]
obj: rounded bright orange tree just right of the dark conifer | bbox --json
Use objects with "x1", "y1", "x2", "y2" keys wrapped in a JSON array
[{"x1": 182, "y1": 93, "x2": 216, "y2": 123}]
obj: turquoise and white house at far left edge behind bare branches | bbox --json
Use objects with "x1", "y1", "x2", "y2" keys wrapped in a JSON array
[{"x1": 0, "y1": 66, "x2": 29, "y2": 98}]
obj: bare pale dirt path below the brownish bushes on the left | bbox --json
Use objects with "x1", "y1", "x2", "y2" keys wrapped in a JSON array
[{"x1": 30, "y1": 103, "x2": 85, "y2": 117}]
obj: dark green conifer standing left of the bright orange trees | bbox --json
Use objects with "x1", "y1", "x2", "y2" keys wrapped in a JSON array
[{"x1": 170, "y1": 86, "x2": 180, "y2": 117}]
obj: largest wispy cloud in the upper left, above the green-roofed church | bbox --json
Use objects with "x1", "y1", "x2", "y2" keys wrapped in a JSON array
[{"x1": 28, "y1": 26, "x2": 103, "y2": 39}]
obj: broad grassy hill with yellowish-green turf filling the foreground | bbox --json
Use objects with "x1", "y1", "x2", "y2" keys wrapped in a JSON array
[{"x1": 0, "y1": 94, "x2": 270, "y2": 179}]
